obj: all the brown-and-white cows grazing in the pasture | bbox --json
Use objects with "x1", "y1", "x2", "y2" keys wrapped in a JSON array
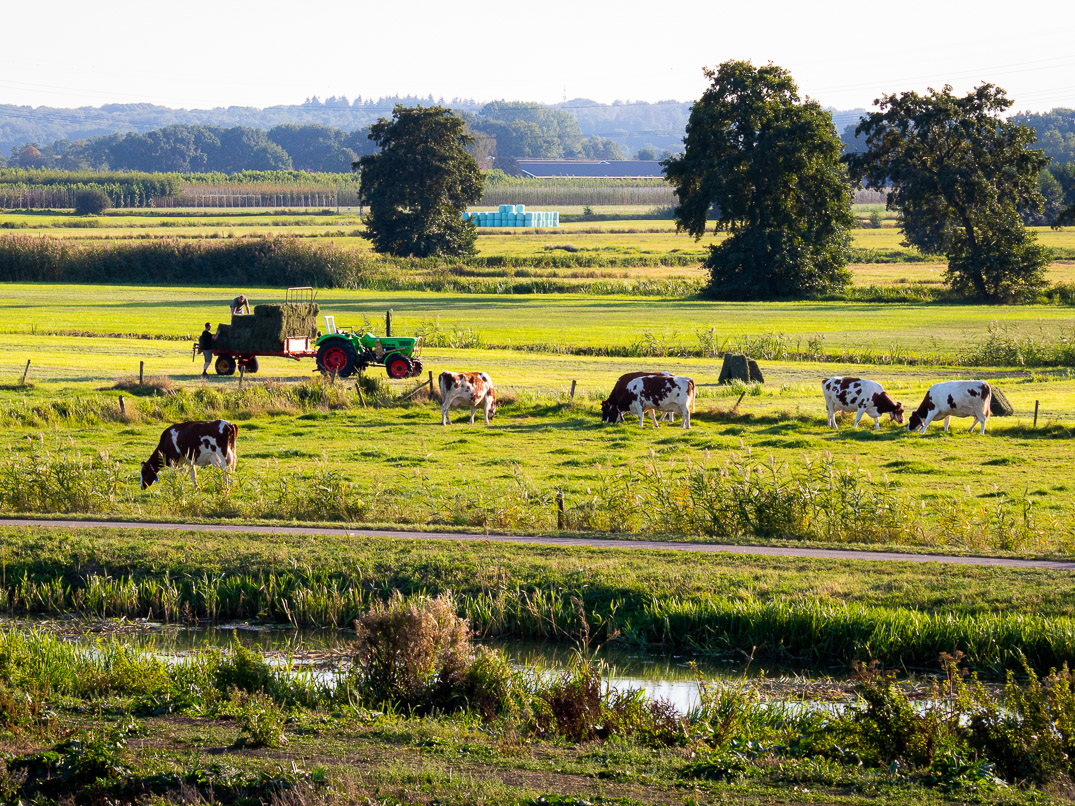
[{"x1": 136, "y1": 372, "x2": 993, "y2": 489}]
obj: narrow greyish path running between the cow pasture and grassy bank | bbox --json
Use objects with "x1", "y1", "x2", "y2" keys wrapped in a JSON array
[{"x1": 0, "y1": 518, "x2": 1075, "y2": 571}]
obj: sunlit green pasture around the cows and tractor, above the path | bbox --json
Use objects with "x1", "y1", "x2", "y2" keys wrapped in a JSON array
[{"x1": 0, "y1": 286, "x2": 1075, "y2": 552}]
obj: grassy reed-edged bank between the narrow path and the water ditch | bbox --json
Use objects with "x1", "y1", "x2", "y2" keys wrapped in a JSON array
[{"x1": 0, "y1": 528, "x2": 1075, "y2": 672}]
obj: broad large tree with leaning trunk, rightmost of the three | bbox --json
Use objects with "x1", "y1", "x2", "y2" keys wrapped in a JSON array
[{"x1": 848, "y1": 84, "x2": 1049, "y2": 301}]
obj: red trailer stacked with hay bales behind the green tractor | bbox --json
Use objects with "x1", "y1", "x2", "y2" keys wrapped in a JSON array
[{"x1": 206, "y1": 286, "x2": 320, "y2": 375}]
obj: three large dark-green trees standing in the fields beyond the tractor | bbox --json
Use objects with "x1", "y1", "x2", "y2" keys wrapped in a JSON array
[{"x1": 365, "y1": 61, "x2": 1075, "y2": 301}]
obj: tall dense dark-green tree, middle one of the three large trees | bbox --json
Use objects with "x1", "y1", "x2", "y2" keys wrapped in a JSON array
[{"x1": 663, "y1": 61, "x2": 854, "y2": 300}]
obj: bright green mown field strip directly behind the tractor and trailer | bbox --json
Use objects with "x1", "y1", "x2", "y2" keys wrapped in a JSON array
[{"x1": 0, "y1": 284, "x2": 1075, "y2": 363}]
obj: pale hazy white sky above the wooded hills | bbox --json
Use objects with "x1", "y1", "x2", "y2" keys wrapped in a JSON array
[{"x1": 0, "y1": 0, "x2": 1075, "y2": 110}]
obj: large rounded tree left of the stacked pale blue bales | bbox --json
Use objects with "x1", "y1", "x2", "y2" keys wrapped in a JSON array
[{"x1": 354, "y1": 106, "x2": 483, "y2": 257}]
